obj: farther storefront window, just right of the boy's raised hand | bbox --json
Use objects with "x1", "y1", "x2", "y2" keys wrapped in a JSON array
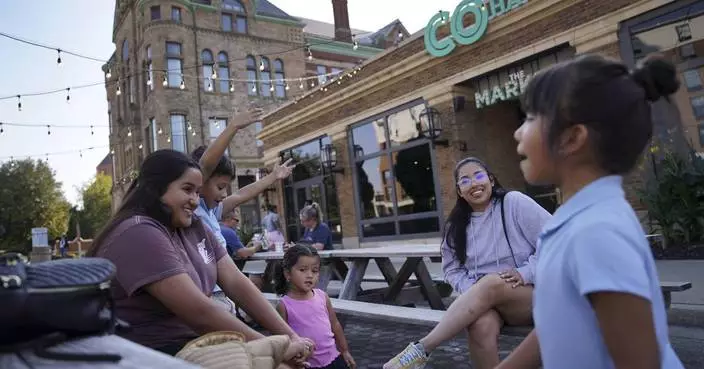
[{"x1": 280, "y1": 136, "x2": 342, "y2": 242}]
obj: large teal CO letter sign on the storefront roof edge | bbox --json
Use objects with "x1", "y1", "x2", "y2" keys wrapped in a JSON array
[{"x1": 425, "y1": 0, "x2": 528, "y2": 57}]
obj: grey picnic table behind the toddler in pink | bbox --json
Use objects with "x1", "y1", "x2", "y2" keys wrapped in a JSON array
[{"x1": 239, "y1": 244, "x2": 445, "y2": 310}]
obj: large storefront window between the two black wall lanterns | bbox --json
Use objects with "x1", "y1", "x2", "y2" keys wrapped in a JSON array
[{"x1": 351, "y1": 102, "x2": 440, "y2": 238}]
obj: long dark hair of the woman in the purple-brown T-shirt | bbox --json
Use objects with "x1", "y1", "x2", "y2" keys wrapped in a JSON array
[{"x1": 88, "y1": 150, "x2": 200, "y2": 256}]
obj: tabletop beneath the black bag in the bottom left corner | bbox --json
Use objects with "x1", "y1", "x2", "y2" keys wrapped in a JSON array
[{"x1": 0, "y1": 335, "x2": 200, "y2": 369}]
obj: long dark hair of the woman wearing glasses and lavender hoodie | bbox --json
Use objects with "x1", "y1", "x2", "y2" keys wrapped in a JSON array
[{"x1": 443, "y1": 157, "x2": 507, "y2": 265}]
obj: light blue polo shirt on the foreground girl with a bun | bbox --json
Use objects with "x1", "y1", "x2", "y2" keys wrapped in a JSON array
[{"x1": 533, "y1": 176, "x2": 683, "y2": 369}]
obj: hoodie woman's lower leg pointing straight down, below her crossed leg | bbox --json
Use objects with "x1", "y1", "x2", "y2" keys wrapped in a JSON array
[{"x1": 467, "y1": 309, "x2": 503, "y2": 369}]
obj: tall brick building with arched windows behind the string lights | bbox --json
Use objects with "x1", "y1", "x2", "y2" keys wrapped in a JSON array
[{"x1": 103, "y1": 0, "x2": 408, "y2": 227}]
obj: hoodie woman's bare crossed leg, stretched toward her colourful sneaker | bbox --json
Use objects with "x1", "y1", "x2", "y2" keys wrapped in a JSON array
[{"x1": 419, "y1": 274, "x2": 508, "y2": 352}]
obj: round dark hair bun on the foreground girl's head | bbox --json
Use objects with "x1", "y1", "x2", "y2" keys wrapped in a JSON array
[{"x1": 631, "y1": 55, "x2": 680, "y2": 101}]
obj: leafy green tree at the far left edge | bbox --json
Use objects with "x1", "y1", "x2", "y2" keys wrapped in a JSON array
[{"x1": 0, "y1": 159, "x2": 70, "y2": 254}]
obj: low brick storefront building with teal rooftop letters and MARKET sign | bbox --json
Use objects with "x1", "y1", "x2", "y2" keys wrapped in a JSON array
[{"x1": 258, "y1": 0, "x2": 704, "y2": 247}]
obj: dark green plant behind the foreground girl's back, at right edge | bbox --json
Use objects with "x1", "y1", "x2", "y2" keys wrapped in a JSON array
[{"x1": 641, "y1": 152, "x2": 704, "y2": 245}]
